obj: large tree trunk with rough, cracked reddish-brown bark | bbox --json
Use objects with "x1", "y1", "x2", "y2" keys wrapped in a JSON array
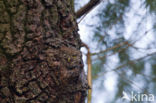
[{"x1": 0, "y1": 0, "x2": 88, "y2": 103}]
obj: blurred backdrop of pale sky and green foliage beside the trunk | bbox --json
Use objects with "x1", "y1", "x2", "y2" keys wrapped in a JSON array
[{"x1": 75, "y1": 0, "x2": 156, "y2": 103}]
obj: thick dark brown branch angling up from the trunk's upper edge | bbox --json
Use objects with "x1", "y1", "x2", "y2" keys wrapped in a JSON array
[{"x1": 76, "y1": 0, "x2": 101, "y2": 18}]
